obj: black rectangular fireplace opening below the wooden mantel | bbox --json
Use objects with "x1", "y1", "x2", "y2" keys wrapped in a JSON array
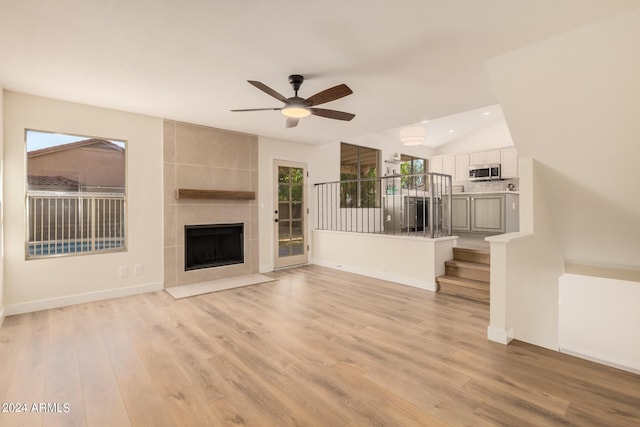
[{"x1": 184, "y1": 224, "x2": 244, "y2": 271}]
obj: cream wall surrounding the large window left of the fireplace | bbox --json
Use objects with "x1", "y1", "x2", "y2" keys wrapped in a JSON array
[{"x1": 3, "y1": 92, "x2": 163, "y2": 313}]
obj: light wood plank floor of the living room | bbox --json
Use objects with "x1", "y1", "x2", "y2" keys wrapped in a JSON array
[{"x1": 0, "y1": 266, "x2": 640, "y2": 427}]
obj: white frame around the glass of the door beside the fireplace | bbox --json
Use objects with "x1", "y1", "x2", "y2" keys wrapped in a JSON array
[{"x1": 272, "y1": 159, "x2": 309, "y2": 270}]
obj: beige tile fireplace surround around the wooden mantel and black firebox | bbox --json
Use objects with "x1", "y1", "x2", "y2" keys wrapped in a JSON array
[{"x1": 164, "y1": 120, "x2": 259, "y2": 288}]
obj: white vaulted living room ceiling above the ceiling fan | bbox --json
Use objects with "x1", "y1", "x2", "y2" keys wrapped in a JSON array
[{"x1": 0, "y1": 0, "x2": 637, "y2": 144}]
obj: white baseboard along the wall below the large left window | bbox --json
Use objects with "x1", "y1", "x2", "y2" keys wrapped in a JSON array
[{"x1": 5, "y1": 283, "x2": 164, "y2": 316}]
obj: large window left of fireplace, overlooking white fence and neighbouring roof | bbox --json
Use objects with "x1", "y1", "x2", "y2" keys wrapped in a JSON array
[{"x1": 25, "y1": 130, "x2": 126, "y2": 259}]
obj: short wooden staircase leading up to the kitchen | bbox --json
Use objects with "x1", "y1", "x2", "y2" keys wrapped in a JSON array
[{"x1": 436, "y1": 248, "x2": 490, "y2": 304}]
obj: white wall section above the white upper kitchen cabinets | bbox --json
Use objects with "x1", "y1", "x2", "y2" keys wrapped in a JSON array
[{"x1": 434, "y1": 118, "x2": 513, "y2": 156}]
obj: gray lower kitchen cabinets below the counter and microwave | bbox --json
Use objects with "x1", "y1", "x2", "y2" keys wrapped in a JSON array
[{"x1": 451, "y1": 193, "x2": 519, "y2": 234}]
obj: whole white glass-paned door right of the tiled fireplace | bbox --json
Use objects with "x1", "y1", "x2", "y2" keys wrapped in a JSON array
[{"x1": 274, "y1": 160, "x2": 307, "y2": 268}]
